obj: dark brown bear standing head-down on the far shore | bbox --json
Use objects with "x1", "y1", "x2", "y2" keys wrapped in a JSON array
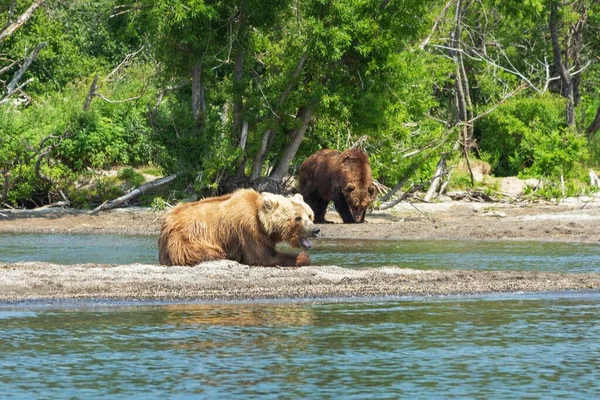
[{"x1": 300, "y1": 148, "x2": 376, "y2": 224}]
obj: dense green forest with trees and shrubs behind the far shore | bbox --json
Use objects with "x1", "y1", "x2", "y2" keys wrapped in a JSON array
[{"x1": 0, "y1": 0, "x2": 600, "y2": 207}]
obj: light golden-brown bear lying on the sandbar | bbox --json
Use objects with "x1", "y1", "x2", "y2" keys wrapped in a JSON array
[{"x1": 158, "y1": 189, "x2": 319, "y2": 266}]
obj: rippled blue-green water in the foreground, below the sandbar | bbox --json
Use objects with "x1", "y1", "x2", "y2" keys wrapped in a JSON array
[{"x1": 0, "y1": 293, "x2": 600, "y2": 399}]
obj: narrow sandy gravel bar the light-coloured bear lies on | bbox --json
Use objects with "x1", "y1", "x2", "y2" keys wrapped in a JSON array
[{"x1": 0, "y1": 261, "x2": 600, "y2": 301}]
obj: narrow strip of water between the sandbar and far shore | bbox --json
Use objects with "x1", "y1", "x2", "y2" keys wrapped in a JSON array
[{"x1": 0, "y1": 234, "x2": 600, "y2": 272}]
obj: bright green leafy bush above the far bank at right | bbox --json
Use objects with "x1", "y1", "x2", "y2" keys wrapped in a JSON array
[{"x1": 476, "y1": 96, "x2": 587, "y2": 178}]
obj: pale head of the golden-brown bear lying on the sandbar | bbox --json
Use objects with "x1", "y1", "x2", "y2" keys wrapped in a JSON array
[{"x1": 258, "y1": 192, "x2": 320, "y2": 250}]
